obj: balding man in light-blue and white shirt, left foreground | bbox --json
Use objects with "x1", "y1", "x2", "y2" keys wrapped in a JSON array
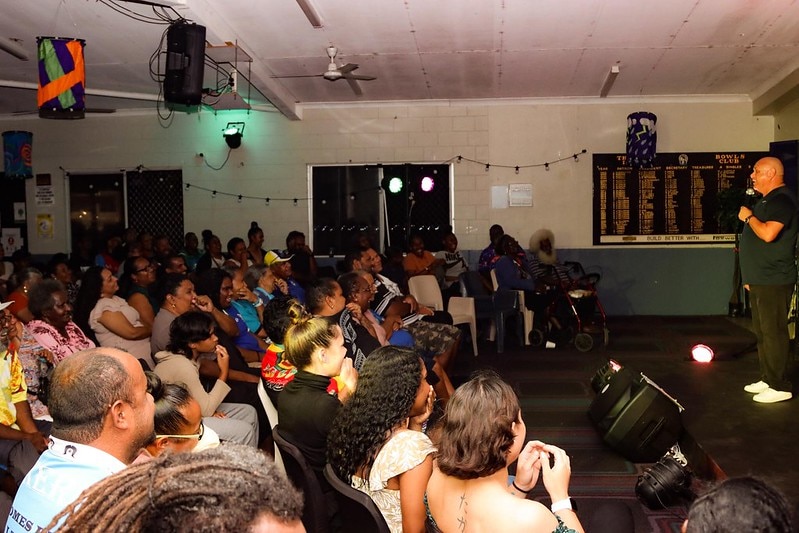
[{"x1": 5, "y1": 347, "x2": 155, "y2": 533}]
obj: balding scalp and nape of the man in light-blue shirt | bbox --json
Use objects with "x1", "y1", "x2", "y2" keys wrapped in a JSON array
[{"x1": 48, "y1": 347, "x2": 142, "y2": 444}]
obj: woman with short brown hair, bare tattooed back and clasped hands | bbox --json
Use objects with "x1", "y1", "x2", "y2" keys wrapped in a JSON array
[{"x1": 427, "y1": 373, "x2": 588, "y2": 533}]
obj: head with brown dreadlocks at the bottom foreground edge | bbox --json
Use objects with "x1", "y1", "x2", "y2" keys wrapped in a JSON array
[{"x1": 45, "y1": 444, "x2": 304, "y2": 533}]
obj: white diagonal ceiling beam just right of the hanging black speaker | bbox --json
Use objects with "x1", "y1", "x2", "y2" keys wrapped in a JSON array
[{"x1": 186, "y1": 0, "x2": 302, "y2": 120}]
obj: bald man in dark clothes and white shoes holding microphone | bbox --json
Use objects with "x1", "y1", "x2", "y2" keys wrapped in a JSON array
[{"x1": 738, "y1": 157, "x2": 799, "y2": 403}]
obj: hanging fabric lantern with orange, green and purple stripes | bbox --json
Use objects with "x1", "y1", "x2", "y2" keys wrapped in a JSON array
[{"x1": 36, "y1": 37, "x2": 86, "y2": 119}]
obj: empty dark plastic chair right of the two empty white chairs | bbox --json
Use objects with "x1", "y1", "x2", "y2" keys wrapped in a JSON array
[{"x1": 460, "y1": 271, "x2": 524, "y2": 353}]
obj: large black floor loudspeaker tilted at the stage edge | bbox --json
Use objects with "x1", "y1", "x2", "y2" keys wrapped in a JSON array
[{"x1": 588, "y1": 362, "x2": 683, "y2": 463}]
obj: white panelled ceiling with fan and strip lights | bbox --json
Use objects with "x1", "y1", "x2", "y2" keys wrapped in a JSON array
[{"x1": 0, "y1": 0, "x2": 799, "y2": 118}]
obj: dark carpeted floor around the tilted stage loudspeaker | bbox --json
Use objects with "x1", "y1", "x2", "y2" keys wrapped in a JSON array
[{"x1": 455, "y1": 317, "x2": 784, "y2": 533}]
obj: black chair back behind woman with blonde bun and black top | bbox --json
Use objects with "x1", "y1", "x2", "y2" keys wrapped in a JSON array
[{"x1": 272, "y1": 424, "x2": 330, "y2": 533}]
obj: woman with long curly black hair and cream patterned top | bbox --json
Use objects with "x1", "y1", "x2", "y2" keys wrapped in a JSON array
[{"x1": 328, "y1": 346, "x2": 434, "y2": 533}]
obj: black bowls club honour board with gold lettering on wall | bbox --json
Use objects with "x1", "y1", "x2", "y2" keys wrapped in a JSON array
[{"x1": 593, "y1": 152, "x2": 768, "y2": 245}]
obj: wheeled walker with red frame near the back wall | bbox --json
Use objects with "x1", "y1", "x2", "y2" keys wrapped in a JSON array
[{"x1": 530, "y1": 262, "x2": 609, "y2": 352}]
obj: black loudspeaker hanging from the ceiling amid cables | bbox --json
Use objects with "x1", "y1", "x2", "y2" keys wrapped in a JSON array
[{"x1": 164, "y1": 22, "x2": 205, "y2": 106}]
